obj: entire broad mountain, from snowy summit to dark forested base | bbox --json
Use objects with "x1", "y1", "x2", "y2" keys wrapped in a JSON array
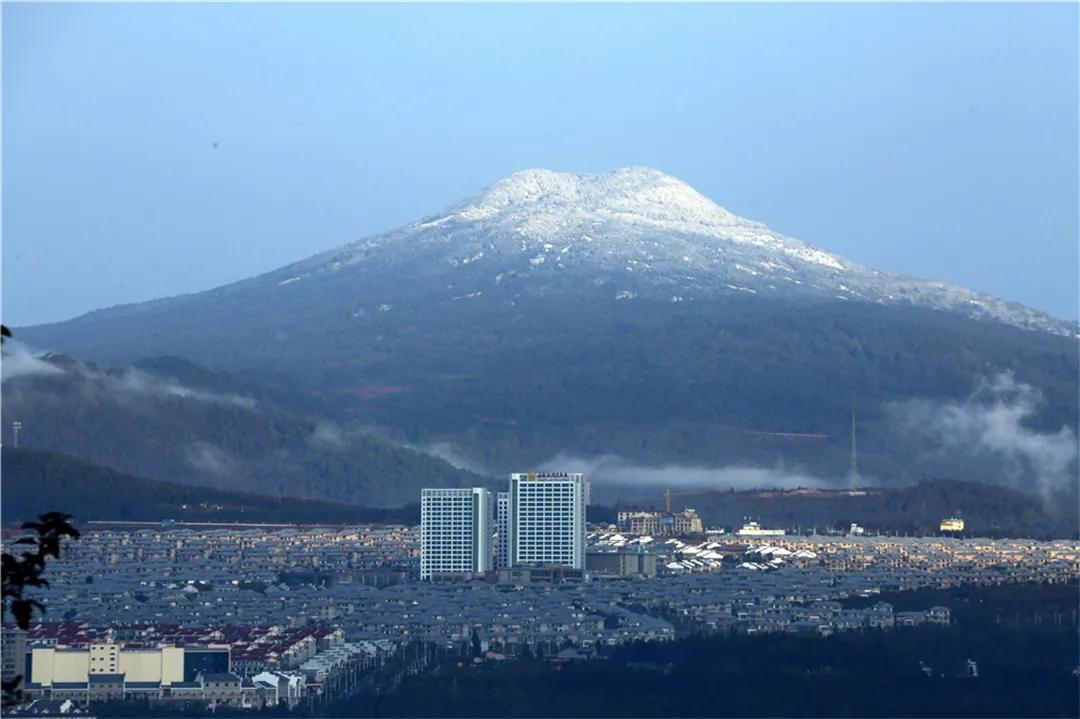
[{"x1": 15, "y1": 167, "x2": 1080, "y2": 481}]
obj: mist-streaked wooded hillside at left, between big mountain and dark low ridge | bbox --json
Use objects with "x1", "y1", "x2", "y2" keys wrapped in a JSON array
[{"x1": 3, "y1": 355, "x2": 483, "y2": 506}]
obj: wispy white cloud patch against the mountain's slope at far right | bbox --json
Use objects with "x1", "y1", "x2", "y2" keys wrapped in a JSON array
[{"x1": 889, "y1": 371, "x2": 1078, "y2": 493}]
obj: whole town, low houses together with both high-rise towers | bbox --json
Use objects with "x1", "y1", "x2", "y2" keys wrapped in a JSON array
[{"x1": 3, "y1": 473, "x2": 1080, "y2": 708}]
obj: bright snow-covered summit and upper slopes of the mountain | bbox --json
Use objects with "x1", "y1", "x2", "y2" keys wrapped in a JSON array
[{"x1": 266, "y1": 167, "x2": 1076, "y2": 335}]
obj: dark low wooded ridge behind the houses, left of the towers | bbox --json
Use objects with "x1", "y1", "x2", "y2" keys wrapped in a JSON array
[{"x1": 2, "y1": 447, "x2": 420, "y2": 524}]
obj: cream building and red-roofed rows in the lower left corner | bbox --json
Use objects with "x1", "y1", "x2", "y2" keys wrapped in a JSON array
[{"x1": 4, "y1": 621, "x2": 399, "y2": 708}]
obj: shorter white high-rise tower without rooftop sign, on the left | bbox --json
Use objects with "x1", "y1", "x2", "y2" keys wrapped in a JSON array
[{"x1": 420, "y1": 487, "x2": 494, "y2": 580}]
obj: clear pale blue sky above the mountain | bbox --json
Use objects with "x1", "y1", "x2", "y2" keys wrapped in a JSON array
[{"x1": 2, "y1": 3, "x2": 1080, "y2": 325}]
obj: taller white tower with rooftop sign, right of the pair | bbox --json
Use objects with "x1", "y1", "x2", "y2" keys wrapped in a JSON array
[{"x1": 509, "y1": 472, "x2": 589, "y2": 569}]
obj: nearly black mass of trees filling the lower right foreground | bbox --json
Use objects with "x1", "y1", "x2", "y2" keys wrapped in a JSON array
[{"x1": 333, "y1": 584, "x2": 1080, "y2": 717}]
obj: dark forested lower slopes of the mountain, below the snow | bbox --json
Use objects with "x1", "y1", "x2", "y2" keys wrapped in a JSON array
[{"x1": 12, "y1": 293, "x2": 1078, "y2": 487}]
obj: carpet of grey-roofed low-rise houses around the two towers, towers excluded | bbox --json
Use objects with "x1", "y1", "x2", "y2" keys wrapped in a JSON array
[{"x1": 4, "y1": 518, "x2": 1080, "y2": 706}]
